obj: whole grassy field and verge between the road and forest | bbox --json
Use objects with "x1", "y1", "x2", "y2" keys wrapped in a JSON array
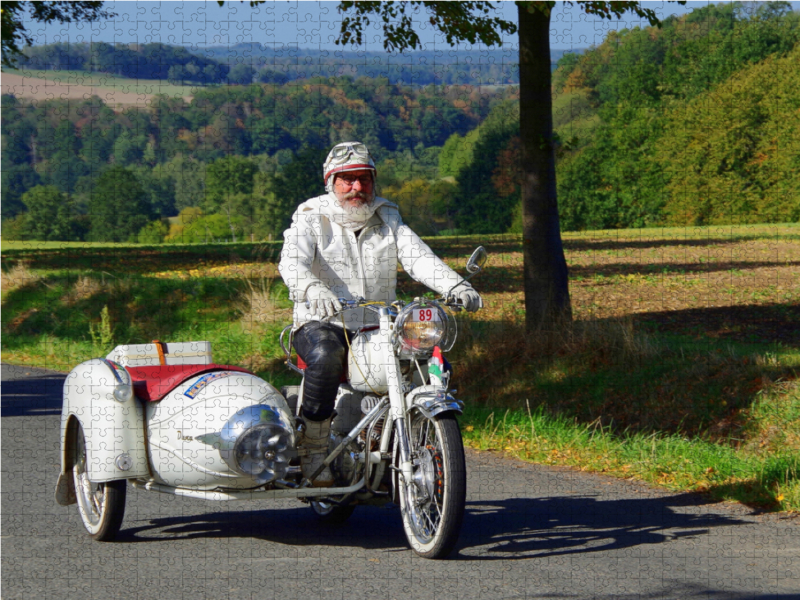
[{"x1": 2, "y1": 225, "x2": 800, "y2": 510}]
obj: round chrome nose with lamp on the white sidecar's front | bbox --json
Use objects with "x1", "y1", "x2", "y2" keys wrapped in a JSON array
[{"x1": 219, "y1": 404, "x2": 294, "y2": 483}]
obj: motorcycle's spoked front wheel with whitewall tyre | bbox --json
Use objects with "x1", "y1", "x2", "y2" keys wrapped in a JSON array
[{"x1": 400, "y1": 412, "x2": 467, "y2": 558}]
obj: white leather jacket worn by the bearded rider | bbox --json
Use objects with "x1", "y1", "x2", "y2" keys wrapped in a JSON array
[{"x1": 278, "y1": 194, "x2": 469, "y2": 329}]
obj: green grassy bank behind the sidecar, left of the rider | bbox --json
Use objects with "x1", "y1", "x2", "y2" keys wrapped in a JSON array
[{"x1": 2, "y1": 271, "x2": 291, "y2": 386}]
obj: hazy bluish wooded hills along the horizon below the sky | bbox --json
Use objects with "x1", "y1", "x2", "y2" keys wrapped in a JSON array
[{"x1": 9, "y1": 42, "x2": 583, "y2": 85}]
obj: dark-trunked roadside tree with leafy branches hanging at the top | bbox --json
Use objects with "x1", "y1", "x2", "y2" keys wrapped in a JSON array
[{"x1": 337, "y1": 1, "x2": 685, "y2": 330}]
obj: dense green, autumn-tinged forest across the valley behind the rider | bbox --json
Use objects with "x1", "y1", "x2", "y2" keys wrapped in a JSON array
[{"x1": 2, "y1": 2, "x2": 800, "y2": 243}]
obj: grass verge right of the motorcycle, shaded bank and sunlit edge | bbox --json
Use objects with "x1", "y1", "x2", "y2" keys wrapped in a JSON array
[{"x1": 452, "y1": 320, "x2": 800, "y2": 511}]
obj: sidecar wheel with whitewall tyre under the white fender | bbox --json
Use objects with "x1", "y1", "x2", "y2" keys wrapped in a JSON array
[{"x1": 72, "y1": 425, "x2": 128, "y2": 542}]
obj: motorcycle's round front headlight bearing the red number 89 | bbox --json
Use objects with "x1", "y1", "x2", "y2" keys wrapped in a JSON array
[{"x1": 394, "y1": 301, "x2": 456, "y2": 356}]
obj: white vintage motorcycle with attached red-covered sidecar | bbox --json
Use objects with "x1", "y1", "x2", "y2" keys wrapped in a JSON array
[{"x1": 55, "y1": 247, "x2": 488, "y2": 559}]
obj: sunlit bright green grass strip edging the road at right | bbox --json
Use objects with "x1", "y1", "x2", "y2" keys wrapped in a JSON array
[{"x1": 462, "y1": 396, "x2": 800, "y2": 511}]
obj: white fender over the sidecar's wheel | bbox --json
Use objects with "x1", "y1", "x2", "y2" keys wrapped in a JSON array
[{"x1": 56, "y1": 358, "x2": 149, "y2": 504}]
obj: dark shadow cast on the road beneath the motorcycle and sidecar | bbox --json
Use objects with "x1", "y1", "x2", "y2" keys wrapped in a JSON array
[{"x1": 117, "y1": 494, "x2": 746, "y2": 560}]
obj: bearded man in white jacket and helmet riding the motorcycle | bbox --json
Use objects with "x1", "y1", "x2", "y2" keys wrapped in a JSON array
[{"x1": 278, "y1": 142, "x2": 483, "y2": 486}]
